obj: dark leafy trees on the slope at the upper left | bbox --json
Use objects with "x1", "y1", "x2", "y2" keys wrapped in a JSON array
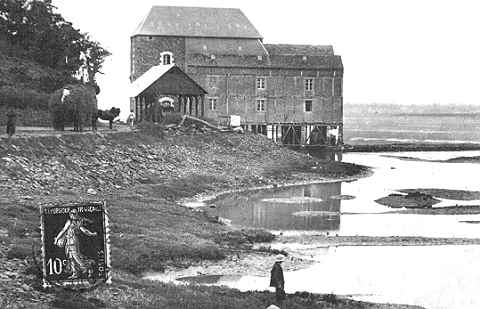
[{"x1": 0, "y1": 0, "x2": 110, "y2": 85}]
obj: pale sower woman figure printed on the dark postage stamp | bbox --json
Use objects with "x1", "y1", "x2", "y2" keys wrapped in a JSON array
[{"x1": 54, "y1": 212, "x2": 97, "y2": 279}]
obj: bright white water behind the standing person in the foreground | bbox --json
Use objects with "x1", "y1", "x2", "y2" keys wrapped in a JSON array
[{"x1": 202, "y1": 246, "x2": 480, "y2": 309}]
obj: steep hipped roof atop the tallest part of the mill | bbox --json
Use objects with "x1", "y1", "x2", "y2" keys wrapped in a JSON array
[{"x1": 132, "y1": 6, "x2": 262, "y2": 39}]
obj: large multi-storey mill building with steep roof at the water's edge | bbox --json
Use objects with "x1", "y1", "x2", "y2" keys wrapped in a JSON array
[{"x1": 130, "y1": 6, "x2": 343, "y2": 145}]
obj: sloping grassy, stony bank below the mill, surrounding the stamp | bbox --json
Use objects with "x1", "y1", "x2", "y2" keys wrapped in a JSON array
[{"x1": 0, "y1": 132, "x2": 420, "y2": 308}]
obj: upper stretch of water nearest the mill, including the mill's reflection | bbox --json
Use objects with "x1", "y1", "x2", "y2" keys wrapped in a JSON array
[{"x1": 215, "y1": 151, "x2": 480, "y2": 238}]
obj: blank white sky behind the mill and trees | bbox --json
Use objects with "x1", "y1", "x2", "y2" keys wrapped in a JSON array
[{"x1": 53, "y1": 0, "x2": 480, "y2": 115}]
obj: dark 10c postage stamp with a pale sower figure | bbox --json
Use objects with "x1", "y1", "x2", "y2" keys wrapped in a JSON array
[{"x1": 40, "y1": 202, "x2": 111, "y2": 288}]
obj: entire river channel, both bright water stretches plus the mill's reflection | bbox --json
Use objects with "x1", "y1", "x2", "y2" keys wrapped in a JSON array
[{"x1": 155, "y1": 151, "x2": 480, "y2": 309}]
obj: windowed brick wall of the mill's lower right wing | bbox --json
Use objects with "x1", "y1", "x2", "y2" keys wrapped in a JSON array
[{"x1": 189, "y1": 67, "x2": 343, "y2": 123}]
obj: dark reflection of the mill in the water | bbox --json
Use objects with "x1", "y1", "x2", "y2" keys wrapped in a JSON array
[{"x1": 215, "y1": 182, "x2": 342, "y2": 231}]
